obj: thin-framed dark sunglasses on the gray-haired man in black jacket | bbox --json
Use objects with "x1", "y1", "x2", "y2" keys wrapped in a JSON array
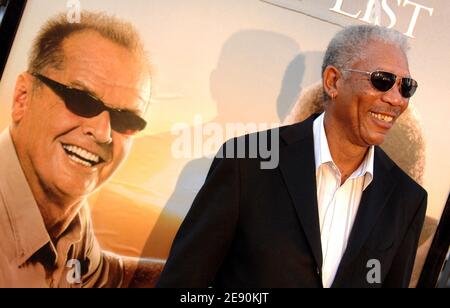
[{"x1": 344, "y1": 69, "x2": 418, "y2": 98}]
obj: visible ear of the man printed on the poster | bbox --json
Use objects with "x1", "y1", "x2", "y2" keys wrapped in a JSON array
[{"x1": 12, "y1": 72, "x2": 33, "y2": 123}]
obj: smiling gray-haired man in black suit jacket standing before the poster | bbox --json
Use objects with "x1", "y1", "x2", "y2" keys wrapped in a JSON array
[{"x1": 158, "y1": 25, "x2": 427, "y2": 288}]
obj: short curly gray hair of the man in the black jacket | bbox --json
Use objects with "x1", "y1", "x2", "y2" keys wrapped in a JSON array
[{"x1": 322, "y1": 25, "x2": 409, "y2": 100}]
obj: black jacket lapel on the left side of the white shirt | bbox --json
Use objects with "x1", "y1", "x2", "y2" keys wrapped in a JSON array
[{"x1": 280, "y1": 115, "x2": 322, "y2": 268}]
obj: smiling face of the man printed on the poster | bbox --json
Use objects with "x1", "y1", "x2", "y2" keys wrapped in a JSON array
[{"x1": 13, "y1": 31, "x2": 150, "y2": 198}]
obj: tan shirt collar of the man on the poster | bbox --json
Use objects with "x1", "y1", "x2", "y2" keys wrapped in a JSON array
[{"x1": 0, "y1": 129, "x2": 81, "y2": 266}]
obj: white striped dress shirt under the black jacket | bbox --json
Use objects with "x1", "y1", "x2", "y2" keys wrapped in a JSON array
[{"x1": 313, "y1": 113, "x2": 374, "y2": 288}]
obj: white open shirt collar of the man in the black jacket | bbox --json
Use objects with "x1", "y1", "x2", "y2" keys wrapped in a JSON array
[{"x1": 313, "y1": 113, "x2": 375, "y2": 189}]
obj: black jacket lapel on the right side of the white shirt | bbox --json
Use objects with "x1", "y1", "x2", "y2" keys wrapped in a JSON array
[{"x1": 333, "y1": 147, "x2": 397, "y2": 287}]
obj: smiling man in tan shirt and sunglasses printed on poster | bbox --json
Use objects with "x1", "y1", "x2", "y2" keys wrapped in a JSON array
[{"x1": 0, "y1": 12, "x2": 162, "y2": 287}]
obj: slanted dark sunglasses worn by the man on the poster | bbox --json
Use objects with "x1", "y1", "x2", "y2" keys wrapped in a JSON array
[{"x1": 32, "y1": 73, "x2": 147, "y2": 135}]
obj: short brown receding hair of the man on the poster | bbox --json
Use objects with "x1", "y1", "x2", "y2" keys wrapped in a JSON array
[{"x1": 28, "y1": 11, "x2": 150, "y2": 73}]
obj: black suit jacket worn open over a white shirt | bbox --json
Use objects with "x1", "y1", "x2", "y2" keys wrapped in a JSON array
[{"x1": 158, "y1": 115, "x2": 427, "y2": 288}]
